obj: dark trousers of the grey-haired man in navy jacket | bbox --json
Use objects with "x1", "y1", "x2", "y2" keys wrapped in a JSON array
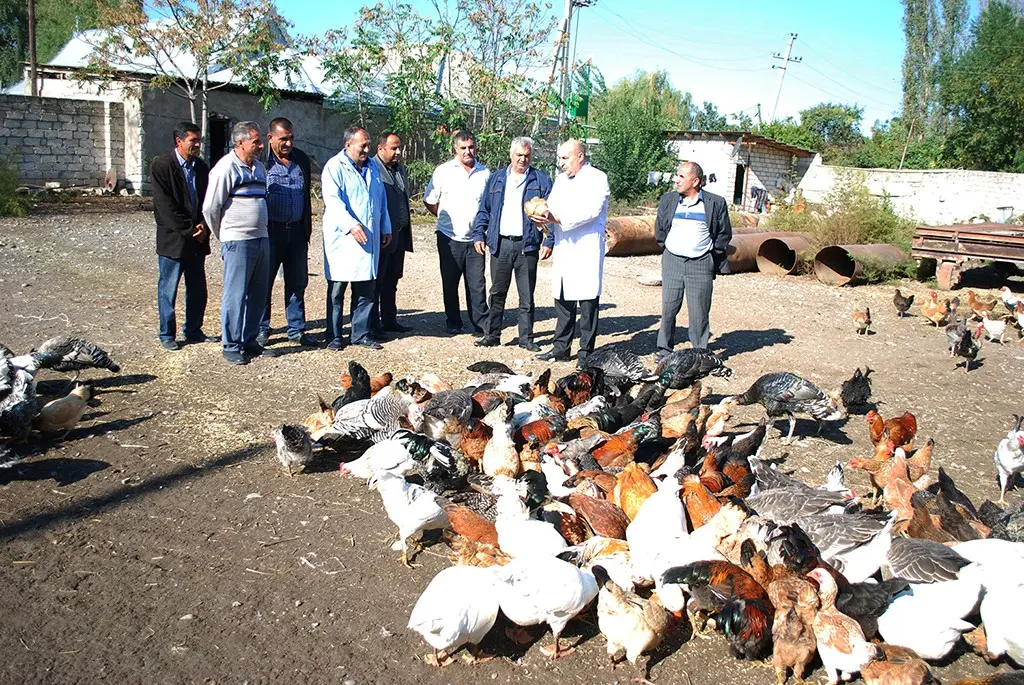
[{"x1": 487, "y1": 236, "x2": 538, "y2": 344}]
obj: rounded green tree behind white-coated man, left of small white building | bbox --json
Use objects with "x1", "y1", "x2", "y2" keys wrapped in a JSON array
[{"x1": 593, "y1": 99, "x2": 677, "y2": 201}]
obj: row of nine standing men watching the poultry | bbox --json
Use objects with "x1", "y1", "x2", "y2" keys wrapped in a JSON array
[{"x1": 151, "y1": 118, "x2": 731, "y2": 367}]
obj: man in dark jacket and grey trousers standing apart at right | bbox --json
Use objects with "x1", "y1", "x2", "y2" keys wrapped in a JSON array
[{"x1": 654, "y1": 162, "x2": 732, "y2": 361}]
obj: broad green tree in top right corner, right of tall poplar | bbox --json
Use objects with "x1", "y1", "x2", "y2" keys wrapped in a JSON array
[{"x1": 942, "y1": 0, "x2": 1024, "y2": 172}]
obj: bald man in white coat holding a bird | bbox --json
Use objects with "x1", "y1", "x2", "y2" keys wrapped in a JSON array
[{"x1": 530, "y1": 140, "x2": 609, "y2": 369}]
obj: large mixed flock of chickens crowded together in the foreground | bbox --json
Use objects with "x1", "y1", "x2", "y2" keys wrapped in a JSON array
[{"x1": 272, "y1": 347, "x2": 1024, "y2": 685}]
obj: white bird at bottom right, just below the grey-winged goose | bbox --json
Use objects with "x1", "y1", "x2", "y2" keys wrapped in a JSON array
[{"x1": 879, "y1": 563, "x2": 982, "y2": 659}]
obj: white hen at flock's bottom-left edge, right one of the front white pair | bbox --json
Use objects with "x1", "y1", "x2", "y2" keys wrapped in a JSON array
[{"x1": 494, "y1": 557, "x2": 598, "y2": 658}]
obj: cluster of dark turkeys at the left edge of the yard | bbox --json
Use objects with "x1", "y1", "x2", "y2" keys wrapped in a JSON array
[{"x1": 0, "y1": 336, "x2": 121, "y2": 468}]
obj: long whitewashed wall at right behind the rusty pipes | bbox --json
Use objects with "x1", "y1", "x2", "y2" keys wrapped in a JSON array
[{"x1": 800, "y1": 165, "x2": 1024, "y2": 225}]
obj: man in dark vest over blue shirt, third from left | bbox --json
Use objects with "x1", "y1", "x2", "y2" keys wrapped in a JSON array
[{"x1": 256, "y1": 117, "x2": 317, "y2": 347}]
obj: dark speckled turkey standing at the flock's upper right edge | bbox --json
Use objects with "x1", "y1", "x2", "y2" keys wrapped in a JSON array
[{"x1": 722, "y1": 372, "x2": 847, "y2": 444}]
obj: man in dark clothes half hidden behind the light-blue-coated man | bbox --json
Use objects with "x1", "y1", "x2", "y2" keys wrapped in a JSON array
[{"x1": 370, "y1": 131, "x2": 413, "y2": 333}]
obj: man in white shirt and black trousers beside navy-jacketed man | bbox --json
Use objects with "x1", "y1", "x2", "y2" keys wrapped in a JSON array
[{"x1": 423, "y1": 130, "x2": 489, "y2": 336}]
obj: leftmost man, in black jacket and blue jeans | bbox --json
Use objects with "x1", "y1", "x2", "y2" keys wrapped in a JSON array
[{"x1": 150, "y1": 122, "x2": 220, "y2": 350}]
